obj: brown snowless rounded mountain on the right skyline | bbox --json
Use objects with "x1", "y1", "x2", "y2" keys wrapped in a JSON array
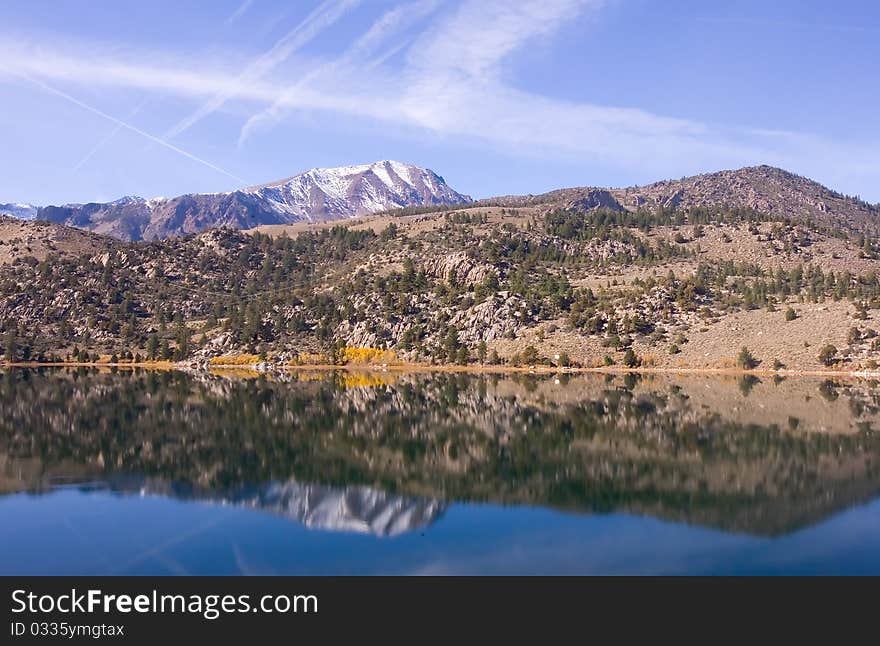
[{"x1": 476, "y1": 166, "x2": 880, "y2": 235}]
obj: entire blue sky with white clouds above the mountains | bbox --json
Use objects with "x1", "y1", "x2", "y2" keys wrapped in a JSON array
[{"x1": 0, "y1": 0, "x2": 880, "y2": 204}]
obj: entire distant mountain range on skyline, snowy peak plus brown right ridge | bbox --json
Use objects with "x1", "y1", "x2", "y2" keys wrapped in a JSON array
[{"x1": 0, "y1": 161, "x2": 880, "y2": 240}]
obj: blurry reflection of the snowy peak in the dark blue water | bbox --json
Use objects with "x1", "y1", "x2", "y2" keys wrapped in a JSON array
[{"x1": 109, "y1": 478, "x2": 445, "y2": 536}]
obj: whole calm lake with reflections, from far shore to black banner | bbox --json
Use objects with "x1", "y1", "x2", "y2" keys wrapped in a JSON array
[{"x1": 0, "y1": 368, "x2": 880, "y2": 574}]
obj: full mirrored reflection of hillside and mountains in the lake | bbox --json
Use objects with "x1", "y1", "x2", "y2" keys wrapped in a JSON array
[{"x1": 0, "y1": 369, "x2": 880, "y2": 548}]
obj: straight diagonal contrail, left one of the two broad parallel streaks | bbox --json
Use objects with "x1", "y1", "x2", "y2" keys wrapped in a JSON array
[{"x1": 165, "y1": 0, "x2": 361, "y2": 139}]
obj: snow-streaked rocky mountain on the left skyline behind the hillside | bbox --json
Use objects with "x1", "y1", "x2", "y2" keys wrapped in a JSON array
[{"x1": 17, "y1": 161, "x2": 471, "y2": 240}]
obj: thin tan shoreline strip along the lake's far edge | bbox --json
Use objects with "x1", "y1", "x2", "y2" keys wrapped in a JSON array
[{"x1": 0, "y1": 361, "x2": 880, "y2": 379}]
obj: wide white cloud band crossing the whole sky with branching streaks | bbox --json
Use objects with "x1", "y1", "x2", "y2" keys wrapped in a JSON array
[{"x1": 0, "y1": 0, "x2": 880, "y2": 199}]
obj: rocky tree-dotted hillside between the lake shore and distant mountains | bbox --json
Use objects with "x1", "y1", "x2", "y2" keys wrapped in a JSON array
[{"x1": 0, "y1": 165, "x2": 880, "y2": 371}]
